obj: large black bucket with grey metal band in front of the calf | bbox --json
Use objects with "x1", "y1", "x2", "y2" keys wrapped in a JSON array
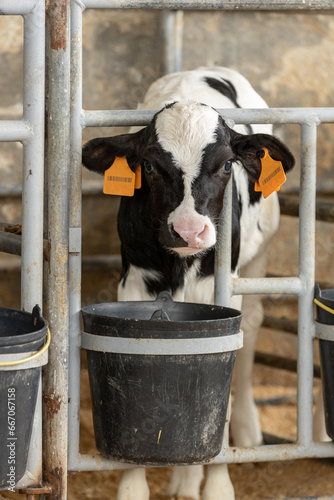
[{"x1": 82, "y1": 292, "x2": 242, "y2": 465}]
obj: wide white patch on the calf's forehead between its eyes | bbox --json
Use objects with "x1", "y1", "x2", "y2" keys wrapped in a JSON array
[{"x1": 156, "y1": 100, "x2": 219, "y2": 180}]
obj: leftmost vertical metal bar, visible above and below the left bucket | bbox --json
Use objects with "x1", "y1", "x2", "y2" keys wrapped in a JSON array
[{"x1": 12, "y1": 0, "x2": 45, "y2": 486}]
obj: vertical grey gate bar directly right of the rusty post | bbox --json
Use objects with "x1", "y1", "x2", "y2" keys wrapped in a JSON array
[{"x1": 68, "y1": 2, "x2": 82, "y2": 469}]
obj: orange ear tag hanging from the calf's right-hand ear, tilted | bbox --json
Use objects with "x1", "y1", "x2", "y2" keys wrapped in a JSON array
[{"x1": 255, "y1": 148, "x2": 286, "y2": 198}]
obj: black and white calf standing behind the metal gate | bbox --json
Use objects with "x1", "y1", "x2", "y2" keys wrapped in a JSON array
[{"x1": 83, "y1": 68, "x2": 294, "y2": 500}]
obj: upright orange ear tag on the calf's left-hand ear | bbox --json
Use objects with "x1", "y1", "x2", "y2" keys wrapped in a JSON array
[{"x1": 103, "y1": 156, "x2": 136, "y2": 196}]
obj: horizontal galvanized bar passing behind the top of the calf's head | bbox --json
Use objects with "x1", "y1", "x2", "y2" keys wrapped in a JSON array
[{"x1": 82, "y1": 108, "x2": 334, "y2": 127}]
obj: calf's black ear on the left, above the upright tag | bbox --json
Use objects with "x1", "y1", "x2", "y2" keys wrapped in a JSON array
[{"x1": 82, "y1": 129, "x2": 146, "y2": 174}]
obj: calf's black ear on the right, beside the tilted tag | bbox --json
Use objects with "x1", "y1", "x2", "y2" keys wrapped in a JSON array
[{"x1": 231, "y1": 131, "x2": 295, "y2": 181}]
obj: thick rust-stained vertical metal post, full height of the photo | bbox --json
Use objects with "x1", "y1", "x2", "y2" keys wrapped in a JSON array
[{"x1": 43, "y1": 0, "x2": 70, "y2": 500}]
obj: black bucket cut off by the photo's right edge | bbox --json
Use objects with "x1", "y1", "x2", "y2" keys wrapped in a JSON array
[{"x1": 315, "y1": 285, "x2": 334, "y2": 439}]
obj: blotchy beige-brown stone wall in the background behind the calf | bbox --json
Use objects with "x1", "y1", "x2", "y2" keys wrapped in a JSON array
[{"x1": 0, "y1": 10, "x2": 334, "y2": 305}]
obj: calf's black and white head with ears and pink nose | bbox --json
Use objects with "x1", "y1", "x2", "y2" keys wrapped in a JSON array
[{"x1": 82, "y1": 100, "x2": 294, "y2": 256}]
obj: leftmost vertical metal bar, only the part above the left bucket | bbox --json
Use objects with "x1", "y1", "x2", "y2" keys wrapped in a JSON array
[{"x1": 21, "y1": 6, "x2": 45, "y2": 311}]
